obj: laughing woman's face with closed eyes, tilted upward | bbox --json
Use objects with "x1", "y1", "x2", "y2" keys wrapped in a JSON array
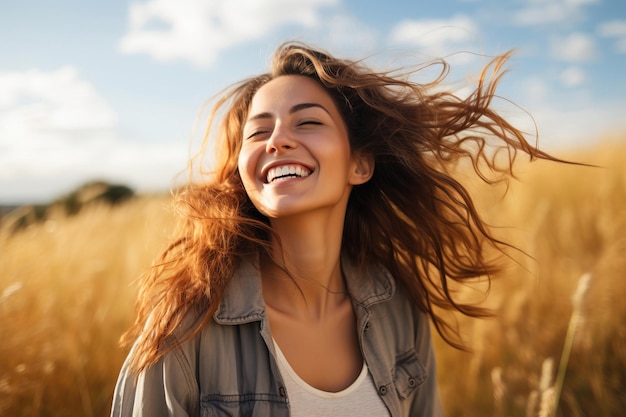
[{"x1": 238, "y1": 75, "x2": 369, "y2": 219}]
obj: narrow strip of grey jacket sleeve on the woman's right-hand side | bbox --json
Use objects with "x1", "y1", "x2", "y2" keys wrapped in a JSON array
[{"x1": 411, "y1": 312, "x2": 443, "y2": 417}]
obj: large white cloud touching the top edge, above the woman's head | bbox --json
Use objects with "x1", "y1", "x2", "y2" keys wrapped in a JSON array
[{"x1": 120, "y1": 0, "x2": 338, "y2": 67}]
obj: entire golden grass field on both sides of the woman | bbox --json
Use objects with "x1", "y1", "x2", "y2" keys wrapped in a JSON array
[{"x1": 0, "y1": 141, "x2": 626, "y2": 417}]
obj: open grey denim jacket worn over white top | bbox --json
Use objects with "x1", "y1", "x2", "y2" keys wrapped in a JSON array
[{"x1": 111, "y1": 255, "x2": 443, "y2": 417}]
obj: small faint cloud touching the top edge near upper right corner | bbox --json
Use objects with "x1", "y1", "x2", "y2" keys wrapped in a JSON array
[{"x1": 513, "y1": 0, "x2": 599, "y2": 26}]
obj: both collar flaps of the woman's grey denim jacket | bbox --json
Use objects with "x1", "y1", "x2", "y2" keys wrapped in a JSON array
[{"x1": 213, "y1": 250, "x2": 395, "y2": 325}]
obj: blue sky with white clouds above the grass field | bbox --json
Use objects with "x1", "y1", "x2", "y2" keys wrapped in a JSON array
[{"x1": 0, "y1": 0, "x2": 626, "y2": 205}]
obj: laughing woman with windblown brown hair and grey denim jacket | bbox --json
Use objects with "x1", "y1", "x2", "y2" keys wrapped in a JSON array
[{"x1": 112, "y1": 40, "x2": 552, "y2": 416}]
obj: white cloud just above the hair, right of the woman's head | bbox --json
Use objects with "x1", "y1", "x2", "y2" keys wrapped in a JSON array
[{"x1": 388, "y1": 15, "x2": 479, "y2": 57}]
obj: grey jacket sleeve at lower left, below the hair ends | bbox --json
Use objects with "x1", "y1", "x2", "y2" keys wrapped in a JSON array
[{"x1": 111, "y1": 342, "x2": 200, "y2": 417}]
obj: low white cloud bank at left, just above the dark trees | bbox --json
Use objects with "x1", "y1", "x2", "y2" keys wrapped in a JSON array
[{"x1": 0, "y1": 140, "x2": 187, "y2": 204}]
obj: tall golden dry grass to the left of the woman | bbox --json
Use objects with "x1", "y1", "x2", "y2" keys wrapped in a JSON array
[{"x1": 0, "y1": 198, "x2": 170, "y2": 417}]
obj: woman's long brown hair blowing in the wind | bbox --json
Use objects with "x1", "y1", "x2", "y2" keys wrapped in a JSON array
[{"x1": 124, "y1": 43, "x2": 554, "y2": 372}]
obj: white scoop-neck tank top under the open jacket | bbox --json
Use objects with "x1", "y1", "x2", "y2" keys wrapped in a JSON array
[{"x1": 274, "y1": 341, "x2": 389, "y2": 417}]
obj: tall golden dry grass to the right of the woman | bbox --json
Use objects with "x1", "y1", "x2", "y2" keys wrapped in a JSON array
[{"x1": 437, "y1": 141, "x2": 626, "y2": 417}]
